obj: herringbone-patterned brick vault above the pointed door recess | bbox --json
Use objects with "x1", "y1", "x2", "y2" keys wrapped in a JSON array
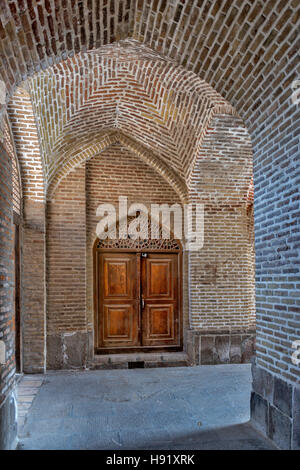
[{"x1": 28, "y1": 41, "x2": 234, "y2": 182}]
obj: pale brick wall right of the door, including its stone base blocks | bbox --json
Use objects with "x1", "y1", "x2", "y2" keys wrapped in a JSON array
[{"x1": 188, "y1": 114, "x2": 255, "y2": 364}]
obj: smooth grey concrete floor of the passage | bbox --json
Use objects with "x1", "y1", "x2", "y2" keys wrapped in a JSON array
[{"x1": 15, "y1": 364, "x2": 273, "y2": 450}]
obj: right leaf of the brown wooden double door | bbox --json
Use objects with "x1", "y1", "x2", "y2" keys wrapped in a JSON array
[{"x1": 142, "y1": 253, "x2": 180, "y2": 347}]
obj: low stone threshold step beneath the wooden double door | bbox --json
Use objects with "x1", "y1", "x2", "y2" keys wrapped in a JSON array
[{"x1": 87, "y1": 351, "x2": 190, "y2": 370}]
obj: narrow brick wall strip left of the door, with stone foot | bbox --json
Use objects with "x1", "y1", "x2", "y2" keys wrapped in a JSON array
[{"x1": 47, "y1": 167, "x2": 88, "y2": 369}]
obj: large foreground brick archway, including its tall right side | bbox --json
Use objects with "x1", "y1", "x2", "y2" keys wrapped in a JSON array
[{"x1": 0, "y1": 0, "x2": 299, "y2": 447}]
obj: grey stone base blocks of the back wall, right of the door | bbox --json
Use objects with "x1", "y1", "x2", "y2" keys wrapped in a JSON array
[{"x1": 185, "y1": 330, "x2": 255, "y2": 365}]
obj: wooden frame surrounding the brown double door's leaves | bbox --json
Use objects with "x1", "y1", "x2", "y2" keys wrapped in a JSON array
[{"x1": 93, "y1": 242, "x2": 183, "y2": 355}]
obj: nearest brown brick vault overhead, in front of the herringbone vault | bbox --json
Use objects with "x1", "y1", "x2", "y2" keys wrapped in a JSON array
[{"x1": 0, "y1": 0, "x2": 300, "y2": 110}]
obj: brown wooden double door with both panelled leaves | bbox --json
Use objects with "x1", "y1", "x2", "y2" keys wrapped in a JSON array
[{"x1": 96, "y1": 252, "x2": 181, "y2": 353}]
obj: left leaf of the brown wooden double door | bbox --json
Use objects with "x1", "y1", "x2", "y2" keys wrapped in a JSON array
[{"x1": 98, "y1": 253, "x2": 140, "y2": 348}]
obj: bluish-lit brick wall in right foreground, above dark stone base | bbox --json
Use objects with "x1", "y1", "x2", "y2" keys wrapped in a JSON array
[{"x1": 248, "y1": 77, "x2": 300, "y2": 388}]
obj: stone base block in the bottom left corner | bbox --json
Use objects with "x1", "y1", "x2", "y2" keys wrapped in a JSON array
[{"x1": 0, "y1": 391, "x2": 18, "y2": 450}]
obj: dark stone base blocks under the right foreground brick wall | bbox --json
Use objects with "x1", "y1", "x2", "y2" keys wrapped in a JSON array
[{"x1": 250, "y1": 364, "x2": 300, "y2": 450}]
